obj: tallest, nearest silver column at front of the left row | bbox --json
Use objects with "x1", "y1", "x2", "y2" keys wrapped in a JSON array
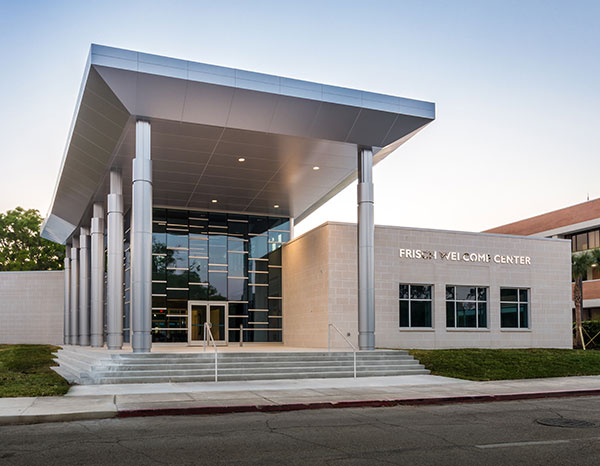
[{"x1": 130, "y1": 121, "x2": 152, "y2": 353}]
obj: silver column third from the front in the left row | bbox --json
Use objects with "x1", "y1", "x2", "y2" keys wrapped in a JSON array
[{"x1": 90, "y1": 202, "x2": 104, "y2": 348}]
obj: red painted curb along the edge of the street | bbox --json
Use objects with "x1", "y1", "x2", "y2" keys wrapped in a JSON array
[{"x1": 117, "y1": 389, "x2": 600, "y2": 417}]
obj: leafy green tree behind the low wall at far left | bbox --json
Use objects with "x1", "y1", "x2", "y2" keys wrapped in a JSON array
[{"x1": 0, "y1": 207, "x2": 65, "y2": 271}]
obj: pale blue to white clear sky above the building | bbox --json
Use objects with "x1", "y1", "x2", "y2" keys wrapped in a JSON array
[{"x1": 0, "y1": 0, "x2": 600, "y2": 237}]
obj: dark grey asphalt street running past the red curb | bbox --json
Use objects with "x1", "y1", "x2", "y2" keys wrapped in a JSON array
[{"x1": 0, "y1": 397, "x2": 600, "y2": 466}]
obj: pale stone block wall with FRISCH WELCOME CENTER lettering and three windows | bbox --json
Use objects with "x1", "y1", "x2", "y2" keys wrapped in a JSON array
[{"x1": 283, "y1": 222, "x2": 572, "y2": 348}]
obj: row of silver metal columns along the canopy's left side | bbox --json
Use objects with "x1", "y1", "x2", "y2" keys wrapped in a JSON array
[{"x1": 64, "y1": 121, "x2": 152, "y2": 352}]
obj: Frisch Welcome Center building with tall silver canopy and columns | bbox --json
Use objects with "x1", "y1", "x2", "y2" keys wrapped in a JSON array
[{"x1": 37, "y1": 45, "x2": 572, "y2": 352}]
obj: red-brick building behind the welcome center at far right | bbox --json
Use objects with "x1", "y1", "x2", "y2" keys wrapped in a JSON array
[{"x1": 487, "y1": 199, "x2": 600, "y2": 320}]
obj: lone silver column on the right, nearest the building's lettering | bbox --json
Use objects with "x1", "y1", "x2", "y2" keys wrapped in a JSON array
[{"x1": 357, "y1": 147, "x2": 375, "y2": 350}]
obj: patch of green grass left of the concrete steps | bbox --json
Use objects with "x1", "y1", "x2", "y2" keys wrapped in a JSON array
[{"x1": 0, "y1": 345, "x2": 69, "y2": 398}]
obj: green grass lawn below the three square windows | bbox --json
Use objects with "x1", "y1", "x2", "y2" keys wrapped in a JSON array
[{"x1": 409, "y1": 349, "x2": 600, "y2": 380}]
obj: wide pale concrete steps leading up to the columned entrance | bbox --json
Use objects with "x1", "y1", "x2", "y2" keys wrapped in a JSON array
[{"x1": 53, "y1": 347, "x2": 429, "y2": 384}]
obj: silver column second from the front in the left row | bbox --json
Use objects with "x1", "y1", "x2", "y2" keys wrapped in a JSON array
[{"x1": 106, "y1": 170, "x2": 124, "y2": 349}]
